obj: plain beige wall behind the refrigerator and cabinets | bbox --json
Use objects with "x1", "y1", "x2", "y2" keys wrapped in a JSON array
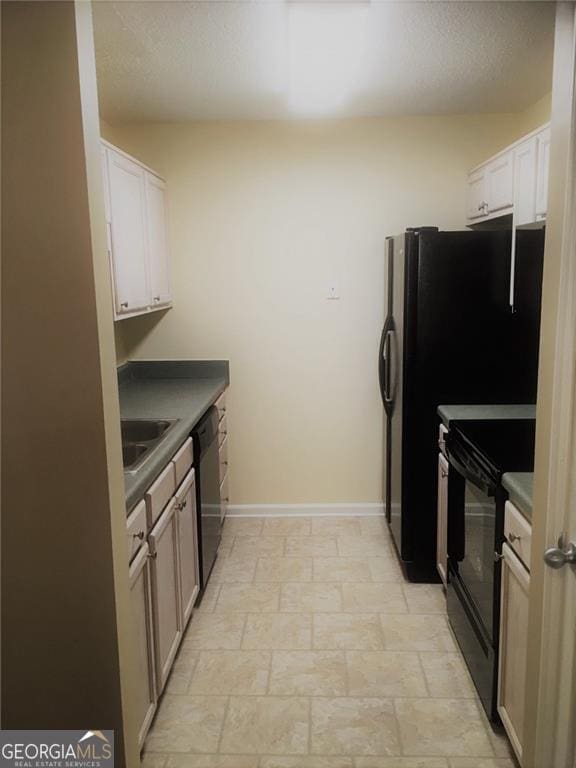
[{"x1": 103, "y1": 109, "x2": 544, "y2": 504}]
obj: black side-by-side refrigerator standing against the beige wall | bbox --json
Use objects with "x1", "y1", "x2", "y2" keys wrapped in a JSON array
[{"x1": 378, "y1": 227, "x2": 544, "y2": 582}]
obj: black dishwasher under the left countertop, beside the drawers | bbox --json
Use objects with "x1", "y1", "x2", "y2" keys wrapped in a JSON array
[{"x1": 192, "y1": 406, "x2": 221, "y2": 592}]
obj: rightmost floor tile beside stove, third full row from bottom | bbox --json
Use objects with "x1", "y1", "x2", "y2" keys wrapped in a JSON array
[{"x1": 381, "y1": 614, "x2": 457, "y2": 651}]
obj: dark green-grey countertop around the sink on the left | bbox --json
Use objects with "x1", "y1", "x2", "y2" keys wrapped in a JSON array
[{"x1": 118, "y1": 360, "x2": 230, "y2": 512}]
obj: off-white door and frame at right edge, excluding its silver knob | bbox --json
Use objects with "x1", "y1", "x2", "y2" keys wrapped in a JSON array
[{"x1": 523, "y1": 7, "x2": 576, "y2": 768}]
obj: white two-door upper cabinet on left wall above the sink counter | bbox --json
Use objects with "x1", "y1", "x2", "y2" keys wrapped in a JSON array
[{"x1": 102, "y1": 143, "x2": 172, "y2": 320}]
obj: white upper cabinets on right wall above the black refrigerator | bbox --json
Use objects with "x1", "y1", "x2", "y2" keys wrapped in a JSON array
[{"x1": 466, "y1": 121, "x2": 550, "y2": 227}]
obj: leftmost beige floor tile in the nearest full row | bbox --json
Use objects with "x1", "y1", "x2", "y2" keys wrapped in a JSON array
[{"x1": 146, "y1": 695, "x2": 228, "y2": 753}]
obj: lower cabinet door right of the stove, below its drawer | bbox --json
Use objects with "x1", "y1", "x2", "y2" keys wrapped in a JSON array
[{"x1": 498, "y1": 544, "x2": 530, "y2": 763}]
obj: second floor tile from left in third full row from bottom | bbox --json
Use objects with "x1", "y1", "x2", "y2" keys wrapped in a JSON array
[{"x1": 242, "y1": 613, "x2": 312, "y2": 650}]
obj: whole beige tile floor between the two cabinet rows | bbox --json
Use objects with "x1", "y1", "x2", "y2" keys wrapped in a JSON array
[{"x1": 143, "y1": 517, "x2": 515, "y2": 768}]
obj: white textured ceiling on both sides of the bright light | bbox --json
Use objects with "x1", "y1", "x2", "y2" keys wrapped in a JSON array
[{"x1": 93, "y1": 0, "x2": 554, "y2": 122}]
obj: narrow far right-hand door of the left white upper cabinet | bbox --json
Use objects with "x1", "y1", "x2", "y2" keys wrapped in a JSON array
[{"x1": 145, "y1": 171, "x2": 172, "y2": 307}]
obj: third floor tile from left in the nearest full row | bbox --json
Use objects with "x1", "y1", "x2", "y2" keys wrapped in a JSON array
[{"x1": 311, "y1": 698, "x2": 400, "y2": 755}]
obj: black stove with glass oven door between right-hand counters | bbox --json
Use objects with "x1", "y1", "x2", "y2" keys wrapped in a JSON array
[{"x1": 445, "y1": 419, "x2": 535, "y2": 722}]
